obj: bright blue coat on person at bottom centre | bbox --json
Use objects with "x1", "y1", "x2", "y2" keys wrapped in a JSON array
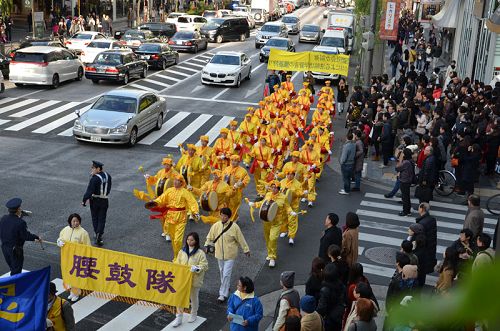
[{"x1": 227, "y1": 291, "x2": 264, "y2": 331}]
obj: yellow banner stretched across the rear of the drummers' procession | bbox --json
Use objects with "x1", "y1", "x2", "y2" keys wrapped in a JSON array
[{"x1": 267, "y1": 48, "x2": 350, "y2": 76}]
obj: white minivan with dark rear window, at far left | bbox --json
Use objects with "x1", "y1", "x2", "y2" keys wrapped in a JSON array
[{"x1": 9, "y1": 46, "x2": 83, "y2": 88}]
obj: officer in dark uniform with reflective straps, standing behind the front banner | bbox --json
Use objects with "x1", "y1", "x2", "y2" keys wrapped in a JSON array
[{"x1": 82, "y1": 161, "x2": 111, "y2": 246}]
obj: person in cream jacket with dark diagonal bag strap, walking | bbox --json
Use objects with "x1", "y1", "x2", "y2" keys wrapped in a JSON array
[{"x1": 205, "y1": 208, "x2": 250, "y2": 303}]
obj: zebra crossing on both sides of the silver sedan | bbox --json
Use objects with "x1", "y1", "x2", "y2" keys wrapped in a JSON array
[{"x1": 0, "y1": 97, "x2": 235, "y2": 148}]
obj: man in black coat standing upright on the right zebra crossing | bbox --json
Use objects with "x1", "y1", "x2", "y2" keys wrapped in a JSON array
[{"x1": 416, "y1": 202, "x2": 437, "y2": 286}]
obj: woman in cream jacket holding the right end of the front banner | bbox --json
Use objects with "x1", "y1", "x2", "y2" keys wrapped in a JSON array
[{"x1": 173, "y1": 232, "x2": 208, "y2": 327}]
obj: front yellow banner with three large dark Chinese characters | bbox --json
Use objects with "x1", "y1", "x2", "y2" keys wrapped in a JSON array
[{"x1": 61, "y1": 242, "x2": 192, "y2": 308}]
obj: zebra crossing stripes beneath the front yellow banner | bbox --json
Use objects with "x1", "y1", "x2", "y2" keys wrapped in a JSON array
[{"x1": 0, "y1": 270, "x2": 206, "y2": 331}]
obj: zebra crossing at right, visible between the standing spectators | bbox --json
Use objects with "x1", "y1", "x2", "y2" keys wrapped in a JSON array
[{"x1": 356, "y1": 193, "x2": 497, "y2": 286}]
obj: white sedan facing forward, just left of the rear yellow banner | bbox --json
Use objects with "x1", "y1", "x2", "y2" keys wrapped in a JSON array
[{"x1": 201, "y1": 52, "x2": 252, "y2": 87}]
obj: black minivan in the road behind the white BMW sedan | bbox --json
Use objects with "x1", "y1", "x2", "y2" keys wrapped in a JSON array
[{"x1": 200, "y1": 17, "x2": 250, "y2": 44}]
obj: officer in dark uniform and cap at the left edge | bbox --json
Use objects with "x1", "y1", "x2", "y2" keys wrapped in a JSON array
[{"x1": 0, "y1": 198, "x2": 42, "y2": 276}]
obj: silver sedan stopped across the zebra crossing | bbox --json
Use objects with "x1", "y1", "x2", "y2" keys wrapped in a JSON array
[{"x1": 73, "y1": 89, "x2": 167, "y2": 146}]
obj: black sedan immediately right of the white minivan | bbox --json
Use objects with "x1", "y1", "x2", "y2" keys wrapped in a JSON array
[{"x1": 85, "y1": 50, "x2": 148, "y2": 85}]
